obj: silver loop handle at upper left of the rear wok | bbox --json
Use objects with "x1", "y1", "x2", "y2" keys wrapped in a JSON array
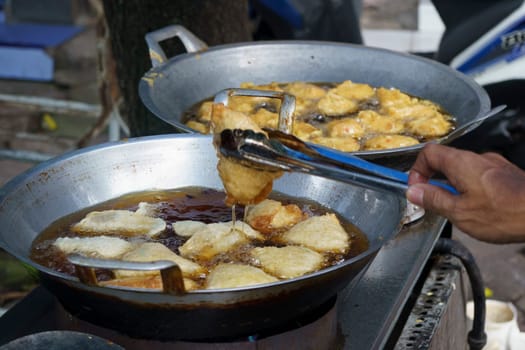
[{"x1": 145, "y1": 25, "x2": 208, "y2": 67}]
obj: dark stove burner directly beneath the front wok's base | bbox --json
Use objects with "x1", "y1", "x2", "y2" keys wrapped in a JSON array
[{"x1": 55, "y1": 297, "x2": 338, "y2": 350}]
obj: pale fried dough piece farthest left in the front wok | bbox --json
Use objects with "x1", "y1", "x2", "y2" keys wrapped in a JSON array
[{"x1": 53, "y1": 236, "x2": 133, "y2": 259}]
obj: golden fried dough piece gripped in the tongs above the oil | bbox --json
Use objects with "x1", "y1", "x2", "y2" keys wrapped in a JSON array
[{"x1": 212, "y1": 104, "x2": 283, "y2": 205}]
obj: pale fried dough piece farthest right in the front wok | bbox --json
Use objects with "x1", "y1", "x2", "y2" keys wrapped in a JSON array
[{"x1": 281, "y1": 213, "x2": 350, "y2": 253}]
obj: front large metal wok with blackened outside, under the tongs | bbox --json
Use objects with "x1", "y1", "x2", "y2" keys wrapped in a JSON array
[{"x1": 0, "y1": 134, "x2": 406, "y2": 339}]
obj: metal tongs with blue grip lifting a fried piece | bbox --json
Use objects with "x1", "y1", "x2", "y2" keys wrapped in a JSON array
[{"x1": 214, "y1": 129, "x2": 458, "y2": 196}]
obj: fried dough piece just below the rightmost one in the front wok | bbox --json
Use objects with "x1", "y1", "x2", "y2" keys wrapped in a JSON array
[{"x1": 250, "y1": 246, "x2": 323, "y2": 278}]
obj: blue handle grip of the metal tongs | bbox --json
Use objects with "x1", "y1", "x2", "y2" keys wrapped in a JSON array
[{"x1": 287, "y1": 143, "x2": 459, "y2": 195}]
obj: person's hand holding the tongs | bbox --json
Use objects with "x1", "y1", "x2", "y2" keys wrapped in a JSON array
[{"x1": 407, "y1": 144, "x2": 525, "y2": 243}]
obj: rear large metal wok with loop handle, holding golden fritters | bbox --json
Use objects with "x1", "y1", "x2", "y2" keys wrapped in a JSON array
[{"x1": 139, "y1": 25, "x2": 490, "y2": 170}]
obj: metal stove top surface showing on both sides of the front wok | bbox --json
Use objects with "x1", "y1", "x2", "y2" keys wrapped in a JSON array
[{"x1": 0, "y1": 213, "x2": 446, "y2": 349}]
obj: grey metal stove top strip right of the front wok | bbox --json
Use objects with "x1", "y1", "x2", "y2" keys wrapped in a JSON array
[{"x1": 338, "y1": 212, "x2": 446, "y2": 349}]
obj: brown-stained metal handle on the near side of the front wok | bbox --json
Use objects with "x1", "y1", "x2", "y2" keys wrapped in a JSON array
[{"x1": 67, "y1": 254, "x2": 186, "y2": 295}]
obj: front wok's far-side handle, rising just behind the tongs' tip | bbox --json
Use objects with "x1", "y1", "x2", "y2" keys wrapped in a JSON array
[{"x1": 213, "y1": 88, "x2": 295, "y2": 134}]
